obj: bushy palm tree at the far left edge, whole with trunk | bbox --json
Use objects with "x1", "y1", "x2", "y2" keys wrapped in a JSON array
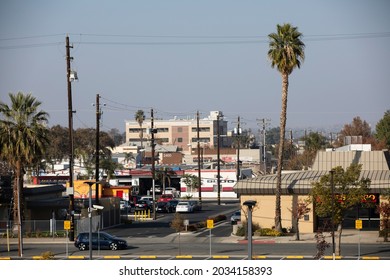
[{"x1": 0, "y1": 92, "x2": 49, "y2": 255}]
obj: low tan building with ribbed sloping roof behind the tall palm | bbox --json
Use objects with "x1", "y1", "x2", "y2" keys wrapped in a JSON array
[{"x1": 234, "y1": 145, "x2": 390, "y2": 233}]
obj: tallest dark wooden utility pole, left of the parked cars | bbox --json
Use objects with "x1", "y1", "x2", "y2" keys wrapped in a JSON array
[{"x1": 65, "y1": 36, "x2": 74, "y2": 241}]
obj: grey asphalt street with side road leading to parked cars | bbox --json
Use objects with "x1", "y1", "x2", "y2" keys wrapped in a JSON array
[{"x1": 0, "y1": 201, "x2": 390, "y2": 259}]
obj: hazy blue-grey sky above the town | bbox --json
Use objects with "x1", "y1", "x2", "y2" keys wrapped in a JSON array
[{"x1": 0, "y1": 0, "x2": 390, "y2": 136}]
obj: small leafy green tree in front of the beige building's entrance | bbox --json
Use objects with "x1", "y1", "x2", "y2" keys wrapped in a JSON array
[{"x1": 310, "y1": 163, "x2": 370, "y2": 255}]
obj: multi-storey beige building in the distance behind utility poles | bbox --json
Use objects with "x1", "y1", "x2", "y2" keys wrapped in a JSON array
[{"x1": 126, "y1": 111, "x2": 230, "y2": 151}]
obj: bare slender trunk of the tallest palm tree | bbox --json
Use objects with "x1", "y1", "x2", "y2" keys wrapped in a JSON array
[{"x1": 275, "y1": 73, "x2": 288, "y2": 232}]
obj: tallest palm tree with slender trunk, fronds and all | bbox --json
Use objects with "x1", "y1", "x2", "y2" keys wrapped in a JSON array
[{"x1": 268, "y1": 24, "x2": 305, "y2": 232}]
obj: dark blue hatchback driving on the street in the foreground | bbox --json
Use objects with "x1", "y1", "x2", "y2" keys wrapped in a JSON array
[{"x1": 74, "y1": 231, "x2": 127, "y2": 251}]
